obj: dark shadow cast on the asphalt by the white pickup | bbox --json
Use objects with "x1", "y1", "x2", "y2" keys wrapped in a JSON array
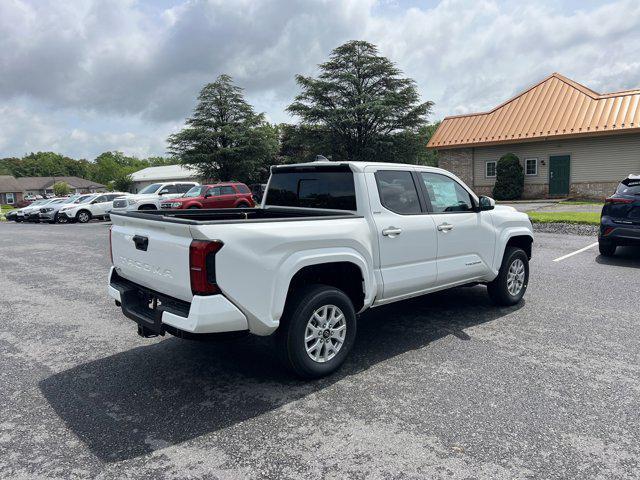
[{"x1": 39, "y1": 287, "x2": 522, "y2": 462}]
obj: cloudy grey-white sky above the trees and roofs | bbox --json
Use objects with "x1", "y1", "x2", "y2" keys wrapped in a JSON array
[{"x1": 0, "y1": 0, "x2": 640, "y2": 158}]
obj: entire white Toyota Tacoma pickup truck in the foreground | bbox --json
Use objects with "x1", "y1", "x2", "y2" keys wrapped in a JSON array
[{"x1": 108, "y1": 161, "x2": 533, "y2": 378}]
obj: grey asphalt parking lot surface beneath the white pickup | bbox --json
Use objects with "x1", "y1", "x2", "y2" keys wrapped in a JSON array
[{"x1": 0, "y1": 223, "x2": 640, "y2": 479}]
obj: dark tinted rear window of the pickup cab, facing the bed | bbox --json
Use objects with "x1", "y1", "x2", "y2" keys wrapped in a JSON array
[{"x1": 266, "y1": 166, "x2": 357, "y2": 210}]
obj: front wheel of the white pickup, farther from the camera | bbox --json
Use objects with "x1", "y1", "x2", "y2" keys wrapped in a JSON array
[{"x1": 487, "y1": 247, "x2": 529, "y2": 306}]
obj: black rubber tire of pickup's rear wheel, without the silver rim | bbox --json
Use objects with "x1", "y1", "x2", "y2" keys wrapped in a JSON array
[{"x1": 276, "y1": 285, "x2": 357, "y2": 379}]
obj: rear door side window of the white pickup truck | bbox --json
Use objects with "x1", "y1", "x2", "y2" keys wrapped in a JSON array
[{"x1": 376, "y1": 170, "x2": 421, "y2": 215}]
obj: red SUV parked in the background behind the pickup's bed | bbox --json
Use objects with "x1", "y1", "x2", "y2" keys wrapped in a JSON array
[{"x1": 160, "y1": 182, "x2": 255, "y2": 209}]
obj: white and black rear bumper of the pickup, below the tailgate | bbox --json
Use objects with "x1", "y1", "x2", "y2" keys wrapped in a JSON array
[{"x1": 108, "y1": 267, "x2": 249, "y2": 336}]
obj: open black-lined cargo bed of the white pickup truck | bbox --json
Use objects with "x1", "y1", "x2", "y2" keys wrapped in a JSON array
[{"x1": 111, "y1": 207, "x2": 360, "y2": 225}]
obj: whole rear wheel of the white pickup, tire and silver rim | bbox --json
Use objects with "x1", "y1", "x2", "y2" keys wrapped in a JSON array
[{"x1": 277, "y1": 285, "x2": 357, "y2": 378}]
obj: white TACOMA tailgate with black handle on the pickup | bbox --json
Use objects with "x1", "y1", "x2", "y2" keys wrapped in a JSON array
[{"x1": 111, "y1": 215, "x2": 193, "y2": 302}]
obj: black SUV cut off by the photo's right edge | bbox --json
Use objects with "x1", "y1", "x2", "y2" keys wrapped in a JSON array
[{"x1": 598, "y1": 175, "x2": 640, "y2": 257}]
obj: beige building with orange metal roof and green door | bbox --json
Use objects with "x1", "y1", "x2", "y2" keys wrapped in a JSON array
[{"x1": 427, "y1": 73, "x2": 640, "y2": 198}]
